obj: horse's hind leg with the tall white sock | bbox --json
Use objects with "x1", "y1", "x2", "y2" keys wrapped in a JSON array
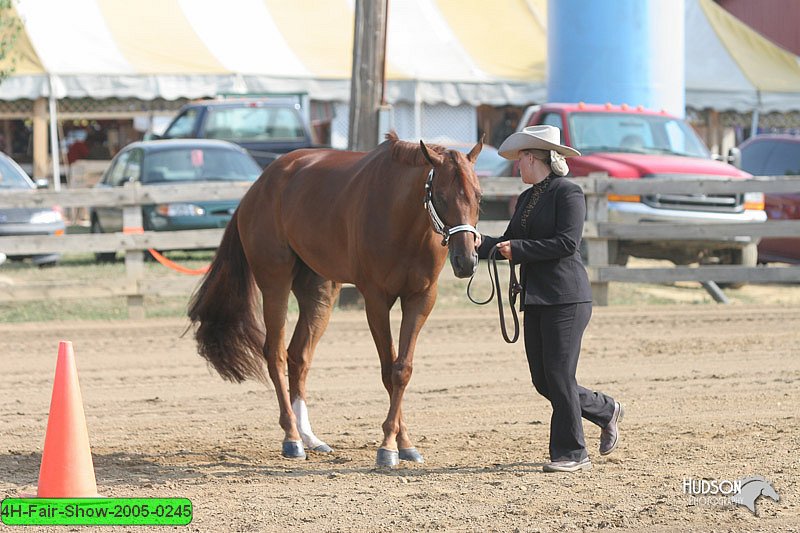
[{"x1": 289, "y1": 265, "x2": 341, "y2": 453}]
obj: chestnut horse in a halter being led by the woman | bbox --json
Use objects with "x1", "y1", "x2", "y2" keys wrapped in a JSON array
[{"x1": 189, "y1": 133, "x2": 483, "y2": 466}]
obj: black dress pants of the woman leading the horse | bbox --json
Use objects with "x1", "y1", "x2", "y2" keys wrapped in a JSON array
[{"x1": 524, "y1": 302, "x2": 614, "y2": 461}]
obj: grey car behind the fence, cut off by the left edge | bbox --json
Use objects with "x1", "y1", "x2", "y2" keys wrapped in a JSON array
[{"x1": 0, "y1": 152, "x2": 66, "y2": 266}]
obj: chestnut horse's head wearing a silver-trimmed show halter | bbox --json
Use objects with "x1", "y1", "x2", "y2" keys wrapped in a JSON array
[{"x1": 419, "y1": 138, "x2": 483, "y2": 278}]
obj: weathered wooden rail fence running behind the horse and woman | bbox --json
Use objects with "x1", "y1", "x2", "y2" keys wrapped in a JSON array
[{"x1": 0, "y1": 176, "x2": 800, "y2": 318}]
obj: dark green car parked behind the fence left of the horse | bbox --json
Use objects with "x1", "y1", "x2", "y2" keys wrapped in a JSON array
[{"x1": 91, "y1": 139, "x2": 261, "y2": 261}]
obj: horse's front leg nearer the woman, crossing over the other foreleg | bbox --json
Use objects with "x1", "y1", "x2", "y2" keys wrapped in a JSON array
[{"x1": 377, "y1": 286, "x2": 436, "y2": 466}]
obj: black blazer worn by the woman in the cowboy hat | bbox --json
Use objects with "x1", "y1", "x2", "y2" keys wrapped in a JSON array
[{"x1": 478, "y1": 175, "x2": 592, "y2": 305}]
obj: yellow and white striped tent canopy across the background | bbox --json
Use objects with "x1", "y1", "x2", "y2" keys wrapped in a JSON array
[{"x1": 0, "y1": 0, "x2": 800, "y2": 111}]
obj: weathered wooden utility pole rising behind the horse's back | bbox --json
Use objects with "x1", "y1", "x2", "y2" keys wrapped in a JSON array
[{"x1": 347, "y1": 0, "x2": 389, "y2": 151}]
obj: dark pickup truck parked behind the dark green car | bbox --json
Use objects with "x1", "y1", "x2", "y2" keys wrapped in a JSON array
[{"x1": 159, "y1": 98, "x2": 313, "y2": 168}]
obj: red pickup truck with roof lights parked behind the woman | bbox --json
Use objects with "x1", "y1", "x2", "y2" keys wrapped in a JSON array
[{"x1": 518, "y1": 103, "x2": 766, "y2": 266}]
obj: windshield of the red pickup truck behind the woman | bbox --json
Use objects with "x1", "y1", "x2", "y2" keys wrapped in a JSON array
[{"x1": 569, "y1": 113, "x2": 711, "y2": 158}]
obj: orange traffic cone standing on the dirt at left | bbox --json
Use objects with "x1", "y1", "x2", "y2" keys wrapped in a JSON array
[{"x1": 37, "y1": 341, "x2": 98, "y2": 498}]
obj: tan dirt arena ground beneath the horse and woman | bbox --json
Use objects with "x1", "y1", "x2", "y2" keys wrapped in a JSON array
[{"x1": 0, "y1": 305, "x2": 800, "y2": 532}]
